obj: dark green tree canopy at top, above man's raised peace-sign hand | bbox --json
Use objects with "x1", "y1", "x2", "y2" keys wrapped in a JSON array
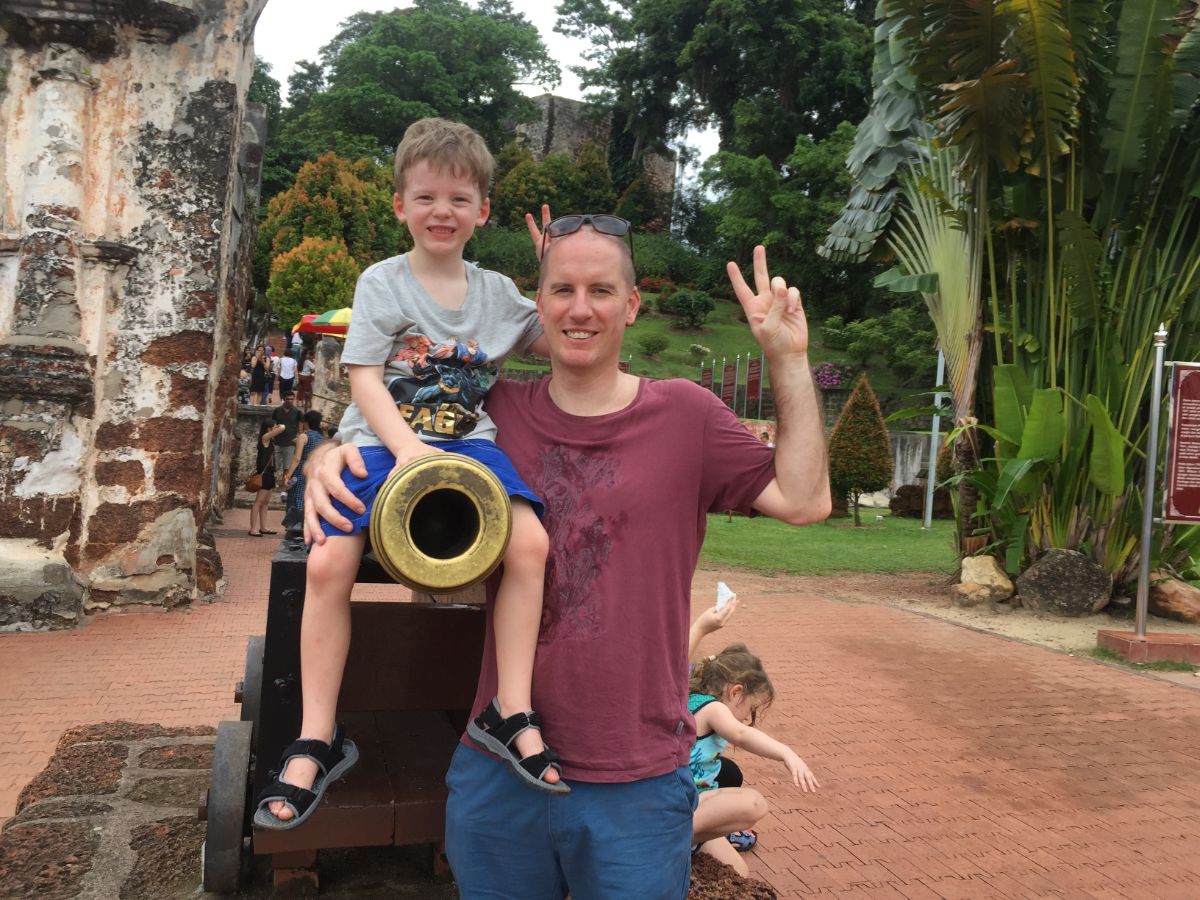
[{"x1": 557, "y1": 0, "x2": 871, "y2": 163}]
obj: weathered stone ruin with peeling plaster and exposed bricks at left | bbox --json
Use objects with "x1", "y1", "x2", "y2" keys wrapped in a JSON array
[{"x1": 0, "y1": 0, "x2": 266, "y2": 629}]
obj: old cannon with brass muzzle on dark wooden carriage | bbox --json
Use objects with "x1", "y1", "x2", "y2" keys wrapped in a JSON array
[{"x1": 199, "y1": 454, "x2": 511, "y2": 892}]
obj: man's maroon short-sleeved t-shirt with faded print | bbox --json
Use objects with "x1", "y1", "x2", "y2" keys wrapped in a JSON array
[{"x1": 464, "y1": 380, "x2": 774, "y2": 781}]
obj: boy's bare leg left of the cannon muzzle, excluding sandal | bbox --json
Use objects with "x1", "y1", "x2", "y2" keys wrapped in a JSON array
[{"x1": 268, "y1": 532, "x2": 366, "y2": 822}]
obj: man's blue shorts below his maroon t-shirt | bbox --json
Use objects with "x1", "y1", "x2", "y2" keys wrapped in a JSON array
[{"x1": 446, "y1": 744, "x2": 696, "y2": 900}]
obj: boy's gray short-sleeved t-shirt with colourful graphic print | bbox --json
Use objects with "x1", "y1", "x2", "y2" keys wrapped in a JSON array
[{"x1": 338, "y1": 256, "x2": 542, "y2": 446}]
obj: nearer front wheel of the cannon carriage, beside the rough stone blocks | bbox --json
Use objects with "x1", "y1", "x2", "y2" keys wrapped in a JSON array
[{"x1": 200, "y1": 721, "x2": 253, "y2": 893}]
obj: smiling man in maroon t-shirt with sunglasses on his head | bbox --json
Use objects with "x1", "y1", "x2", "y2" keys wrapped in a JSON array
[{"x1": 305, "y1": 216, "x2": 830, "y2": 900}]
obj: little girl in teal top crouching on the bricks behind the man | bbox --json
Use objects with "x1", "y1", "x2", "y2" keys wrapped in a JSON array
[{"x1": 688, "y1": 643, "x2": 820, "y2": 876}]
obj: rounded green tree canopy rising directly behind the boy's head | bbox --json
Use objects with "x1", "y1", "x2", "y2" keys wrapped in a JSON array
[{"x1": 259, "y1": 0, "x2": 559, "y2": 197}]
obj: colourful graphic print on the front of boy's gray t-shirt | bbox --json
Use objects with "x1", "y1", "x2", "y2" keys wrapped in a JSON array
[{"x1": 388, "y1": 332, "x2": 496, "y2": 439}]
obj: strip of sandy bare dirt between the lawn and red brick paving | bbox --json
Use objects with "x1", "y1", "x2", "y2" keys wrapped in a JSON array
[{"x1": 710, "y1": 572, "x2": 1200, "y2": 688}]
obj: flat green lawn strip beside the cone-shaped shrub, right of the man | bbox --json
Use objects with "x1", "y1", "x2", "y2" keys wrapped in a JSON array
[{"x1": 701, "y1": 510, "x2": 956, "y2": 575}]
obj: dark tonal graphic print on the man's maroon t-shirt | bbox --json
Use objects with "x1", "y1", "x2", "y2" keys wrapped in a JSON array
[{"x1": 530, "y1": 445, "x2": 625, "y2": 641}]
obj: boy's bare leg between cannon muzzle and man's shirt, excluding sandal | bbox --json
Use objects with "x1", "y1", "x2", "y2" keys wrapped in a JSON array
[{"x1": 492, "y1": 498, "x2": 558, "y2": 784}]
